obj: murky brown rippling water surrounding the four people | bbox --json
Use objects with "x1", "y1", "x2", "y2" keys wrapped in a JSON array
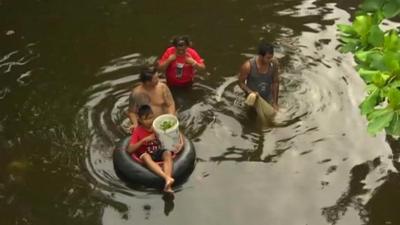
[{"x1": 0, "y1": 0, "x2": 400, "y2": 225}]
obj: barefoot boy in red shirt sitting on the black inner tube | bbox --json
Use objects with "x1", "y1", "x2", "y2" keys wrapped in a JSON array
[{"x1": 127, "y1": 105, "x2": 183, "y2": 193}]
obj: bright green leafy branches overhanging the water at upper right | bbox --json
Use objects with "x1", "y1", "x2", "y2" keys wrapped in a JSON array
[{"x1": 337, "y1": 0, "x2": 400, "y2": 137}]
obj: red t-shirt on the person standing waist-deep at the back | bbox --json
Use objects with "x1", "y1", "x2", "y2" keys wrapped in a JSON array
[{"x1": 159, "y1": 47, "x2": 204, "y2": 86}]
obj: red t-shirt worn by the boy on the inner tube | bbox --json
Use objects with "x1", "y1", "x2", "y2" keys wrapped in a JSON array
[{"x1": 129, "y1": 125, "x2": 161, "y2": 158}]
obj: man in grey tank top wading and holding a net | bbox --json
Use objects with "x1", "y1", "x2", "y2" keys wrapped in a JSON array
[{"x1": 239, "y1": 42, "x2": 279, "y2": 117}]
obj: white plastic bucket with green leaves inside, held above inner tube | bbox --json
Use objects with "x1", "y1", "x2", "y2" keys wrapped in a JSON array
[{"x1": 153, "y1": 114, "x2": 179, "y2": 150}]
